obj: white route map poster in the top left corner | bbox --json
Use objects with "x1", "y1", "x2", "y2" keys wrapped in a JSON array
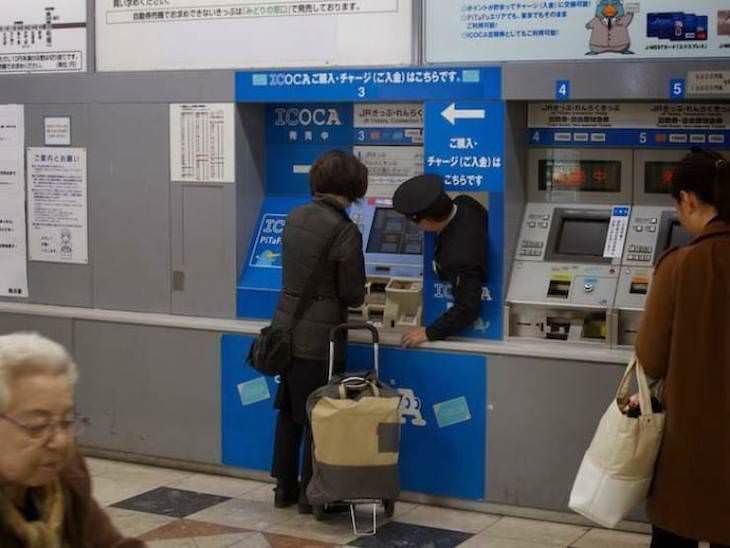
[{"x1": 0, "y1": 0, "x2": 86, "y2": 74}]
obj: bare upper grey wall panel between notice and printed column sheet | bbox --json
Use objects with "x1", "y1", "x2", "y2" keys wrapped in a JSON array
[{"x1": 89, "y1": 103, "x2": 171, "y2": 312}]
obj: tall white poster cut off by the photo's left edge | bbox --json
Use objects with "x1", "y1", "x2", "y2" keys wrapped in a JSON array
[{"x1": 0, "y1": 105, "x2": 28, "y2": 297}]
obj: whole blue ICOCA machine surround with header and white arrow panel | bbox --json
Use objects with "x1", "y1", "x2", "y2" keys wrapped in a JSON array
[{"x1": 236, "y1": 67, "x2": 504, "y2": 339}]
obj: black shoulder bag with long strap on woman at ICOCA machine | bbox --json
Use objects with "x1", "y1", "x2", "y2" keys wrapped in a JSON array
[{"x1": 246, "y1": 225, "x2": 340, "y2": 377}]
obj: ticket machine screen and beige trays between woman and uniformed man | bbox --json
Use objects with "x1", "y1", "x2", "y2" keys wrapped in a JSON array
[{"x1": 350, "y1": 197, "x2": 423, "y2": 329}]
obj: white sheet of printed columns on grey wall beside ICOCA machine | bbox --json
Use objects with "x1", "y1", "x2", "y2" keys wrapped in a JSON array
[{"x1": 170, "y1": 103, "x2": 236, "y2": 183}]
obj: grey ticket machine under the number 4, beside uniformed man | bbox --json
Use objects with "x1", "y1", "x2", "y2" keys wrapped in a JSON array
[{"x1": 505, "y1": 148, "x2": 633, "y2": 345}]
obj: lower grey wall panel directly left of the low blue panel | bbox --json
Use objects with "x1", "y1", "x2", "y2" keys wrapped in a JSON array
[{"x1": 74, "y1": 321, "x2": 221, "y2": 464}]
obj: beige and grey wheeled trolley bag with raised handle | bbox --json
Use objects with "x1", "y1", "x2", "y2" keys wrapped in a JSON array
[{"x1": 307, "y1": 323, "x2": 400, "y2": 535}]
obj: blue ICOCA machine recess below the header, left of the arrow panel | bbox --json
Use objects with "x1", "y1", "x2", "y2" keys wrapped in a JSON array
[{"x1": 238, "y1": 101, "x2": 424, "y2": 329}]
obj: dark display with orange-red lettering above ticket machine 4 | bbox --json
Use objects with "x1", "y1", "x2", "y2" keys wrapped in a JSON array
[{"x1": 538, "y1": 160, "x2": 621, "y2": 192}]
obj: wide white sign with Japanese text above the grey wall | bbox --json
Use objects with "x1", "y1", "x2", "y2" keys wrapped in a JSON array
[{"x1": 96, "y1": 0, "x2": 413, "y2": 71}]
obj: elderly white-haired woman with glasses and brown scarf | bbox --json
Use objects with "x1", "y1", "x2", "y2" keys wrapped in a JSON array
[{"x1": 0, "y1": 333, "x2": 144, "y2": 548}]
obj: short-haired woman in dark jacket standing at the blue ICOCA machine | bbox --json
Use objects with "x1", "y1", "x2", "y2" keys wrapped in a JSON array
[{"x1": 271, "y1": 150, "x2": 368, "y2": 513}]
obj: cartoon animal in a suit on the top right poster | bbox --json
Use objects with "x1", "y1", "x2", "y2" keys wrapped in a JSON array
[{"x1": 586, "y1": 0, "x2": 634, "y2": 55}]
